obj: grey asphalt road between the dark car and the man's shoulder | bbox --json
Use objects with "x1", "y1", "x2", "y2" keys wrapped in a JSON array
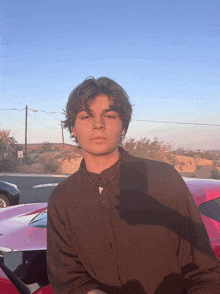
[{"x1": 0, "y1": 175, "x2": 66, "y2": 204}]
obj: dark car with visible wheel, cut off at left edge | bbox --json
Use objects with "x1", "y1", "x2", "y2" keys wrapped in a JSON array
[{"x1": 0, "y1": 181, "x2": 20, "y2": 208}]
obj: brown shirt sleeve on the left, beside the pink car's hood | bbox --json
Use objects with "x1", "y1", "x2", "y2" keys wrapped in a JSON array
[{"x1": 47, "y1": 188, "x2": 102, "y2": 294}]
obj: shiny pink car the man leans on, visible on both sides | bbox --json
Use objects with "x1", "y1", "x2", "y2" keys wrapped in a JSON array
[{"x1": 0, "y1": 178, "x2": 220, "y2": 294}]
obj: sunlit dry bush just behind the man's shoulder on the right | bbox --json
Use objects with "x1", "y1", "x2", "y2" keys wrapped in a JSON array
[{"x1": 121, "y1": 137, "x2": 178, "y2": 165}]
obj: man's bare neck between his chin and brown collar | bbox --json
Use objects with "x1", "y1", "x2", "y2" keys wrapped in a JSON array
[{"x1": 83, "y1": 148, "x2": 119, "y2": 174}]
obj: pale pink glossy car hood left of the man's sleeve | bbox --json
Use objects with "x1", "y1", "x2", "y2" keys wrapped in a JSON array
[{"x1": 0, "y1": 203, "x2": 47, "y2": 251}]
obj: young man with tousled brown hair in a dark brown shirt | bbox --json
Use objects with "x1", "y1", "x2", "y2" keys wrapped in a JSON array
[{"x1": 47, "y1": 77, "x2": 220, "y2": 294}]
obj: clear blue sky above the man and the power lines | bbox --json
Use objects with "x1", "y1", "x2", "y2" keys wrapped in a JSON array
[{"x1": 0, "y1": 0, "x2": 220, "y2": 149}]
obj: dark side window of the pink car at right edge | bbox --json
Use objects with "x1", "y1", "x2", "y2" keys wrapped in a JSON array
[{"x1": 199, "y1": 198, "x2": 220, "y2": 222}]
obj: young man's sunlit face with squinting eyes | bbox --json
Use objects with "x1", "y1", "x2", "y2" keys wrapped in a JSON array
[{"x1": 73, "y1": 94, "x2": 125, "y2": 155}]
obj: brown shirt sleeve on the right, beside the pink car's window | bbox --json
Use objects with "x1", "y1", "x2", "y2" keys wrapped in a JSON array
[{"x1": 171, "y1": 169, "x2": 220, "y2": 294}]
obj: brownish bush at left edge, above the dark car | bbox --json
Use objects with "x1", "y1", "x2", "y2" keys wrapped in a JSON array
[{"x1": 0, "y1": 129, "x2": 22, "y2": 171}]
